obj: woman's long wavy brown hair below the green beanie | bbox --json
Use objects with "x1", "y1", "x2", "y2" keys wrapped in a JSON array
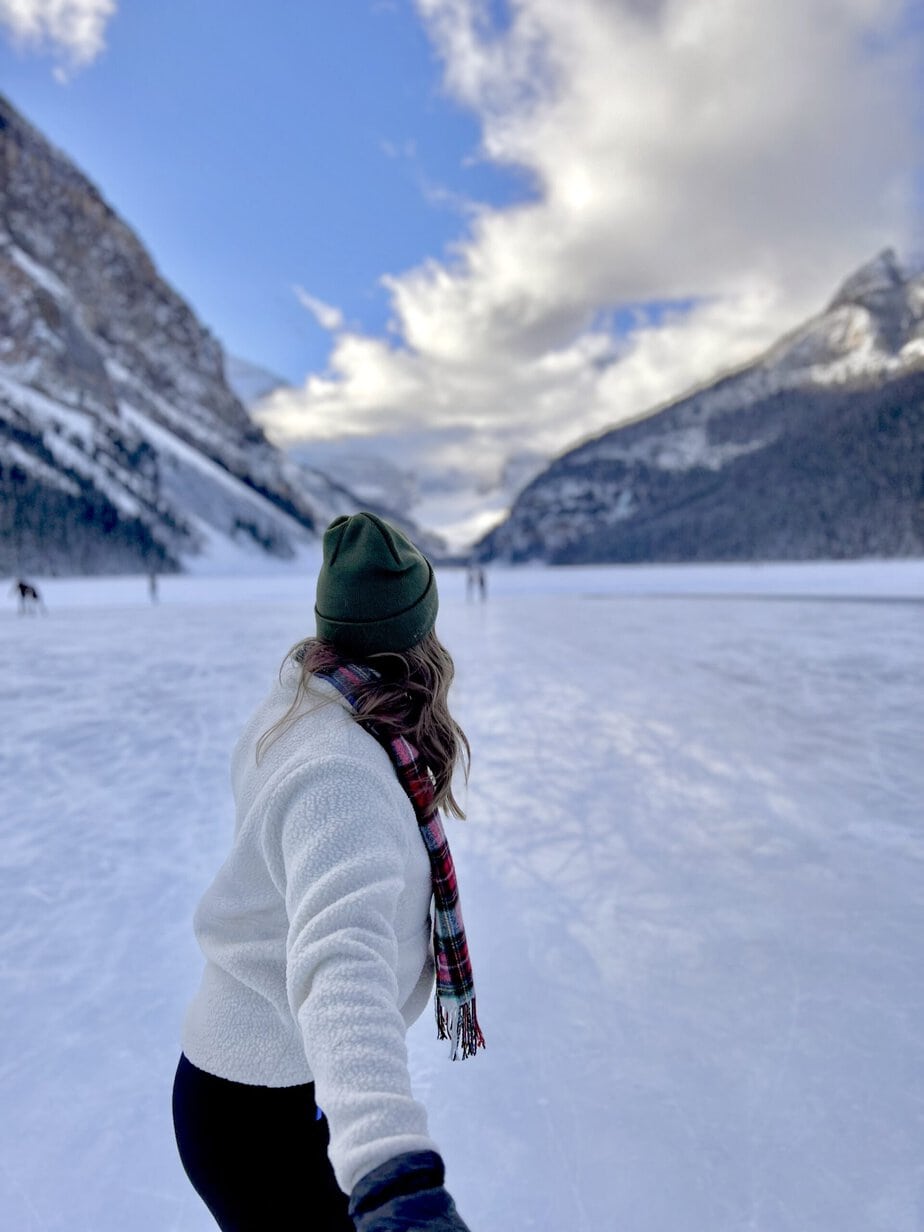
[{"x1": 256, "y1": 631, "x2": 472, "y2": 818}]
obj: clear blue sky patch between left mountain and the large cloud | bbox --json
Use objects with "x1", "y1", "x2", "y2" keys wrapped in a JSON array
[{"x1": 0, "y1": 0, "x2": 526, "y2": 382}]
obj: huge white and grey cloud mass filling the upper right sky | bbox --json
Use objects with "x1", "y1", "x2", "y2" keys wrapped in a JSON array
[{"x1": 258, "y1": 0, "x2": 920, "y2": 549}]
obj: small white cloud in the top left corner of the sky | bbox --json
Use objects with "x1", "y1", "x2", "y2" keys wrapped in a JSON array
[{"x1": 0, "y1": 0, "x2": 117, "y2": 80}]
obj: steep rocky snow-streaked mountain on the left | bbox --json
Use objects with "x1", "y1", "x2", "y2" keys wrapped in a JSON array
[{"x1": 0, "y1": 96, "x2": 426, "y2": 573}]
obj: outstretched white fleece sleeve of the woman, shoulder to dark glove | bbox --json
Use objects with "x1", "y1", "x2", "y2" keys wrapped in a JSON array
[{"x1": 267, "y1": 756, "x2": 435, "y2": 1194}]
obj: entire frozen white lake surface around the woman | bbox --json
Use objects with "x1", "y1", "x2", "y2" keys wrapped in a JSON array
[{"x1": 0, "y1": 562, "x2": 924, "y2": 1232}]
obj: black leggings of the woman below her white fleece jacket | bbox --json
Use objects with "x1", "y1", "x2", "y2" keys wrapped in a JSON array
[{"x1": 174, "y1": 1056, "x2": 355, "y2": 1232}]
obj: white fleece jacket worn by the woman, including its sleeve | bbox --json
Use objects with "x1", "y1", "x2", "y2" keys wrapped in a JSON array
[{"x1": 182, "y1": 659, "x2": 436, "y2": 1194}]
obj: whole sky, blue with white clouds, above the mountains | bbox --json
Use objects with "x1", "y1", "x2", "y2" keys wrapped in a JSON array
[{"x1": 0, "y1": 0, "x2": 924, "y2": 536}]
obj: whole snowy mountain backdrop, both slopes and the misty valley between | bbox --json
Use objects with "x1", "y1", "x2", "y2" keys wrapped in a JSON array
[{"x1": 0, "y1": 85, "x2": 924, "y2": 574}]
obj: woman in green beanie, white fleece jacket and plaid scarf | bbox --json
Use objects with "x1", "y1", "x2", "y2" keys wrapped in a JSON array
[{"x1": 172, "y1": 513, "x2": 489, "y2": 1232}]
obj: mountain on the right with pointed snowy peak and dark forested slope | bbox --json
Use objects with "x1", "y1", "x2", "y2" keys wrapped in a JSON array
[{"x1": 478, "y1": 250, "x2": 924, "y2": 563}]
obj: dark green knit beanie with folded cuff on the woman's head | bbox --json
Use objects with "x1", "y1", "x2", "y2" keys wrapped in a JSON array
[{"x1": 314, "y1": 513, "x2": 439, "y2": 655}]
